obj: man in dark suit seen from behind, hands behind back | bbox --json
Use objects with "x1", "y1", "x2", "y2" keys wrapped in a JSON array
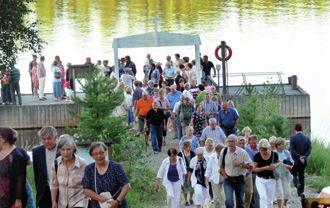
[{"x1": 290, "y1": 124, "x2": 312, "y2": 196}]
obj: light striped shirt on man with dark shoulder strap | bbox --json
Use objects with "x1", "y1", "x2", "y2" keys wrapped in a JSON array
[{"x1": 219, "y1": 147, "x2": 252, "y2": 177}]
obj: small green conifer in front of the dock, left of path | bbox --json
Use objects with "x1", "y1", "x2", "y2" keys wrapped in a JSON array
[{"x1": 73, "y1": 65, "x2": 126, "y2": 142}]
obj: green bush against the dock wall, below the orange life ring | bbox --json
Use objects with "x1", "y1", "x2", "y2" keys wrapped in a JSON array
[{"x1": 238, "y1": 85, "x2": 289, "y2": 138}]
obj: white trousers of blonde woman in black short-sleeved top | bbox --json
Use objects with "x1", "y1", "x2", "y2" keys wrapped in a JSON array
[{"x1": 256, "y1": 176, "x2": 276, "y2": 208}]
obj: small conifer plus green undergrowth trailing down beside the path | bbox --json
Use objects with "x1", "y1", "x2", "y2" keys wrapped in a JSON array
[{"x1": 73, "y1": 66, "x2": 162, "y2": 208}]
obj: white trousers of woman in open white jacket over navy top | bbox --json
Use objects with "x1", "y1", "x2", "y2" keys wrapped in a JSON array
[{"x1": 166, "y1": 181, "x2": 181, "y2": 208}]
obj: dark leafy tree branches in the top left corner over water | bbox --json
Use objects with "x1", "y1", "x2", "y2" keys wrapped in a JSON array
[{"x1": 0, "y1": 0, "x2": 44, "y2": 67}]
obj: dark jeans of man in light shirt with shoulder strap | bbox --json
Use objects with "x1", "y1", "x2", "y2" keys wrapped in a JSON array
[{"x1": 224, "y1": 176, "x2": 244, "y2": 208}]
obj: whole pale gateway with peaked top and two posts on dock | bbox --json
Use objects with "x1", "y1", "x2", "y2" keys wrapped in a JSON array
[{"x1": 112, "y1": 31, "x2": 201, "y2": 82}]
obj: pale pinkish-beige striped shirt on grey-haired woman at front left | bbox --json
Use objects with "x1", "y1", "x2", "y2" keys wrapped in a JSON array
[{"x1": 50, "y1": 155, "x2": 88, "y2": 208}]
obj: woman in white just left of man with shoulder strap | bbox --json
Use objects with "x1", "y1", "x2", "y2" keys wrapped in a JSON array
[{"x1": 205, "y1": 144, "x2": 225, "y2": 207}]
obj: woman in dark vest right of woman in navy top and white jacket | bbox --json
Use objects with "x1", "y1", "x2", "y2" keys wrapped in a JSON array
[{"x1": 178, "y1": 140, "x2": 195, "y2": 206}]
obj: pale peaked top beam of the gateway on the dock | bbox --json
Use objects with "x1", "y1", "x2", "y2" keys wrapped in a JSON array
[{"x1": 112, "y1": 31, "x2": 201, "y2": 48}]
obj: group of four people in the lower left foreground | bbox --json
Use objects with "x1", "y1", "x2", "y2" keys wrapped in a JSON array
[{"x1": 0, "y1": 126, "x2": 130, "y2": 208}]
